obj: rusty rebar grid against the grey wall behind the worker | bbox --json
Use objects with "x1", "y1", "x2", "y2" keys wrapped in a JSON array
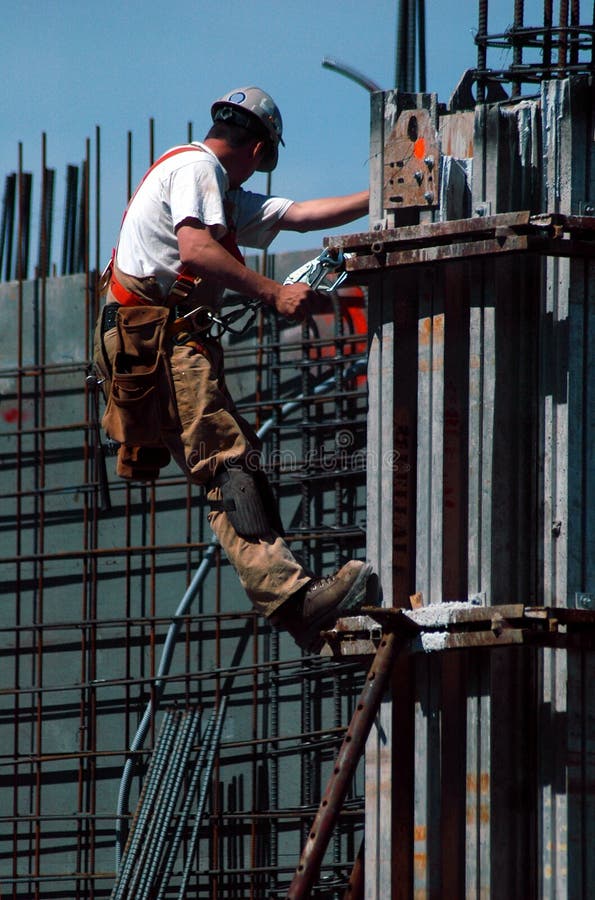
[{"x1": 0, "y1": 123, "x2": 366, "y2": 900}]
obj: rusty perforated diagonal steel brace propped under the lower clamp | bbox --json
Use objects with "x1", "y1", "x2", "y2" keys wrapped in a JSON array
[{"x1": 286, "y1": 632, "x2": 407, "y2": 900}]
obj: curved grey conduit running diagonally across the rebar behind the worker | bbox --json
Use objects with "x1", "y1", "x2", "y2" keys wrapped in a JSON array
[{"x1": 109, "y1": 359, "x2": 366, "y2": 872}]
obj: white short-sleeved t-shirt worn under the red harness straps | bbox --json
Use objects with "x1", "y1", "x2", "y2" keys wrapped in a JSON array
[{"x1": 116, "y1": 142, "x2": 293, "y2": 293}]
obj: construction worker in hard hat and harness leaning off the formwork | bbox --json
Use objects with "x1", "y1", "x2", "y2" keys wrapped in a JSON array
[{"x1": 95, "y1": 87, "x2": 370, "y2": 649}]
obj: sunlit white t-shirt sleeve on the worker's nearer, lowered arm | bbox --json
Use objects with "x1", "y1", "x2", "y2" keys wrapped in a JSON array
[{"x1": 164, "y1": 159, "x2": 227, "y2": 237}]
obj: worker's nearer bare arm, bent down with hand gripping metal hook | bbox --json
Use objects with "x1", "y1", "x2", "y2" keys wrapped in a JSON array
[{"x1": 176, "y1": 219, "x2": 316, "y2": 318}]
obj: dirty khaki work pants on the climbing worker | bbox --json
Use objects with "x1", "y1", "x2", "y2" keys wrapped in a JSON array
[{"x1": 95, "y1": 306, "x2": 311, "y2": 618}]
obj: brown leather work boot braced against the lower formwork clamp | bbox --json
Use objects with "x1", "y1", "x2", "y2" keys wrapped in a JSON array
[{"x1": 273, "y1": 559, "x2": 372, "y2": 652}]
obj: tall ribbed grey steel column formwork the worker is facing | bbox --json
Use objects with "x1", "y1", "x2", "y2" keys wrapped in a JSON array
[{"x1": 358, "y1": 78, "x2": 595, "y2": 900}]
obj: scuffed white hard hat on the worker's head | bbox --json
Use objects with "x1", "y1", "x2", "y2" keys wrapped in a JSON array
[{"x1": 211, "y1": 87, "x2": 285, "y2": 172}]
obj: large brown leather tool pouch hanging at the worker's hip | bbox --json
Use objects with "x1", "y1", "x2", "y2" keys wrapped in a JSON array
[{"x1": 101, "y1": 306, "x2": 180, "y2": 447}]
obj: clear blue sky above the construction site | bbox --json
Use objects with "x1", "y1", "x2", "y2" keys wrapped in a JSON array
[{"x1": 0, "y1": 0, "x2": 542, "y2": 257}]
